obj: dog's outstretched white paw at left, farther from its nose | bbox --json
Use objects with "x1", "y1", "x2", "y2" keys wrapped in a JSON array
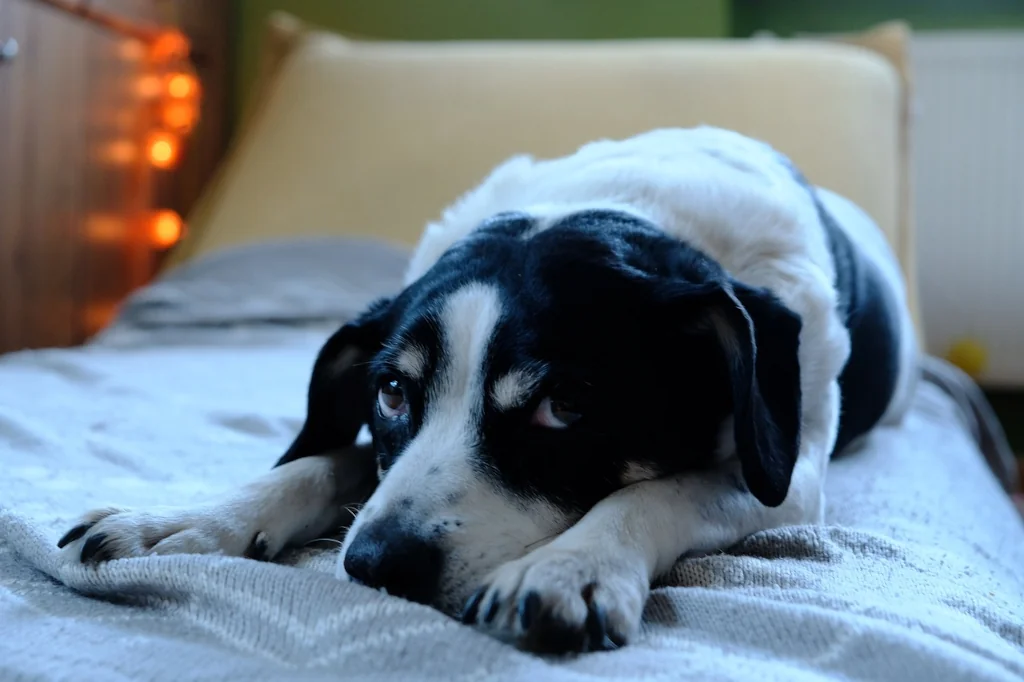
[{"x1": 57, "y1": 508, "x2": 272, "y2": 563}]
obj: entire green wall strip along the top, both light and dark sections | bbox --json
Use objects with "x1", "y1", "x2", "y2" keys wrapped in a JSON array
[{"x1": 231, "y1": 0, "x2": 1024, "y2": 124}]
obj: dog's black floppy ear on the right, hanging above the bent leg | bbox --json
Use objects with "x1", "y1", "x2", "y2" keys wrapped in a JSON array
[{"x1": 696, "y1": 283, "x2": 802, "y2": 507}]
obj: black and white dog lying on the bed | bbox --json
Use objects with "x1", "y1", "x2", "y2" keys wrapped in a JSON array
[{"x1": 59, "y1": 128, "x2": 918, "y2": 652}]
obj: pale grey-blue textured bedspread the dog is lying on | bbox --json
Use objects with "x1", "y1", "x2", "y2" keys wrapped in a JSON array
[{"x1": 0, "y1": 236, "x2": 1024, "y2": 682}]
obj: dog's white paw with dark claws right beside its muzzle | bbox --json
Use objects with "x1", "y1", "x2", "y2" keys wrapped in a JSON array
[{"x1": 463, "y1": 545, "x2": 650, "y2": 653}]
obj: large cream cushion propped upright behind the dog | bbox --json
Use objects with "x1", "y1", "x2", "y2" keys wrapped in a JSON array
[{"x1": 171, "y1": 17, "x2": 913, "y2": 331}]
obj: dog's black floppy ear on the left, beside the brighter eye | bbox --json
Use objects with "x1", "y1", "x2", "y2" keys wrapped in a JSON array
[{"x1": 274, "y1": 299, "x2": 391, "y2": 466}]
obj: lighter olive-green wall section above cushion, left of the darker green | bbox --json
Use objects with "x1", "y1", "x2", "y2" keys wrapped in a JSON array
[{"x1": 232, "y1": 0, "x2": 732, "y2": 125}]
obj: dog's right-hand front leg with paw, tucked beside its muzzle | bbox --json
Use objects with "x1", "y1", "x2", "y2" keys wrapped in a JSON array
[{"x1": 463, "y1": 450, "x2": 822, "y2": 653}]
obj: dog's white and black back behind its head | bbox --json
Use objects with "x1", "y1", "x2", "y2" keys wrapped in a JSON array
[{"x1": 407, "y1": 127, "x2": 918, "y2": 451}]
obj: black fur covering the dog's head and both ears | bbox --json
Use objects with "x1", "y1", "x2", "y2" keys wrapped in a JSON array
[{"x1": 283, "y1": 210, "x2": 800, "y2": 512}]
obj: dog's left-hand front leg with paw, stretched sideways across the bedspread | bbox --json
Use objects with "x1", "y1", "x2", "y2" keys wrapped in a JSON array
[{"x1": 57, "y1": 445, "x2": 377, "y2": 563}]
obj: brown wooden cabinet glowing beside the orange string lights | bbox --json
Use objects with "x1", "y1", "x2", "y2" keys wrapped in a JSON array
[{"x1": 0, "y1": 0, "x2": 229, "y2": 352}]
